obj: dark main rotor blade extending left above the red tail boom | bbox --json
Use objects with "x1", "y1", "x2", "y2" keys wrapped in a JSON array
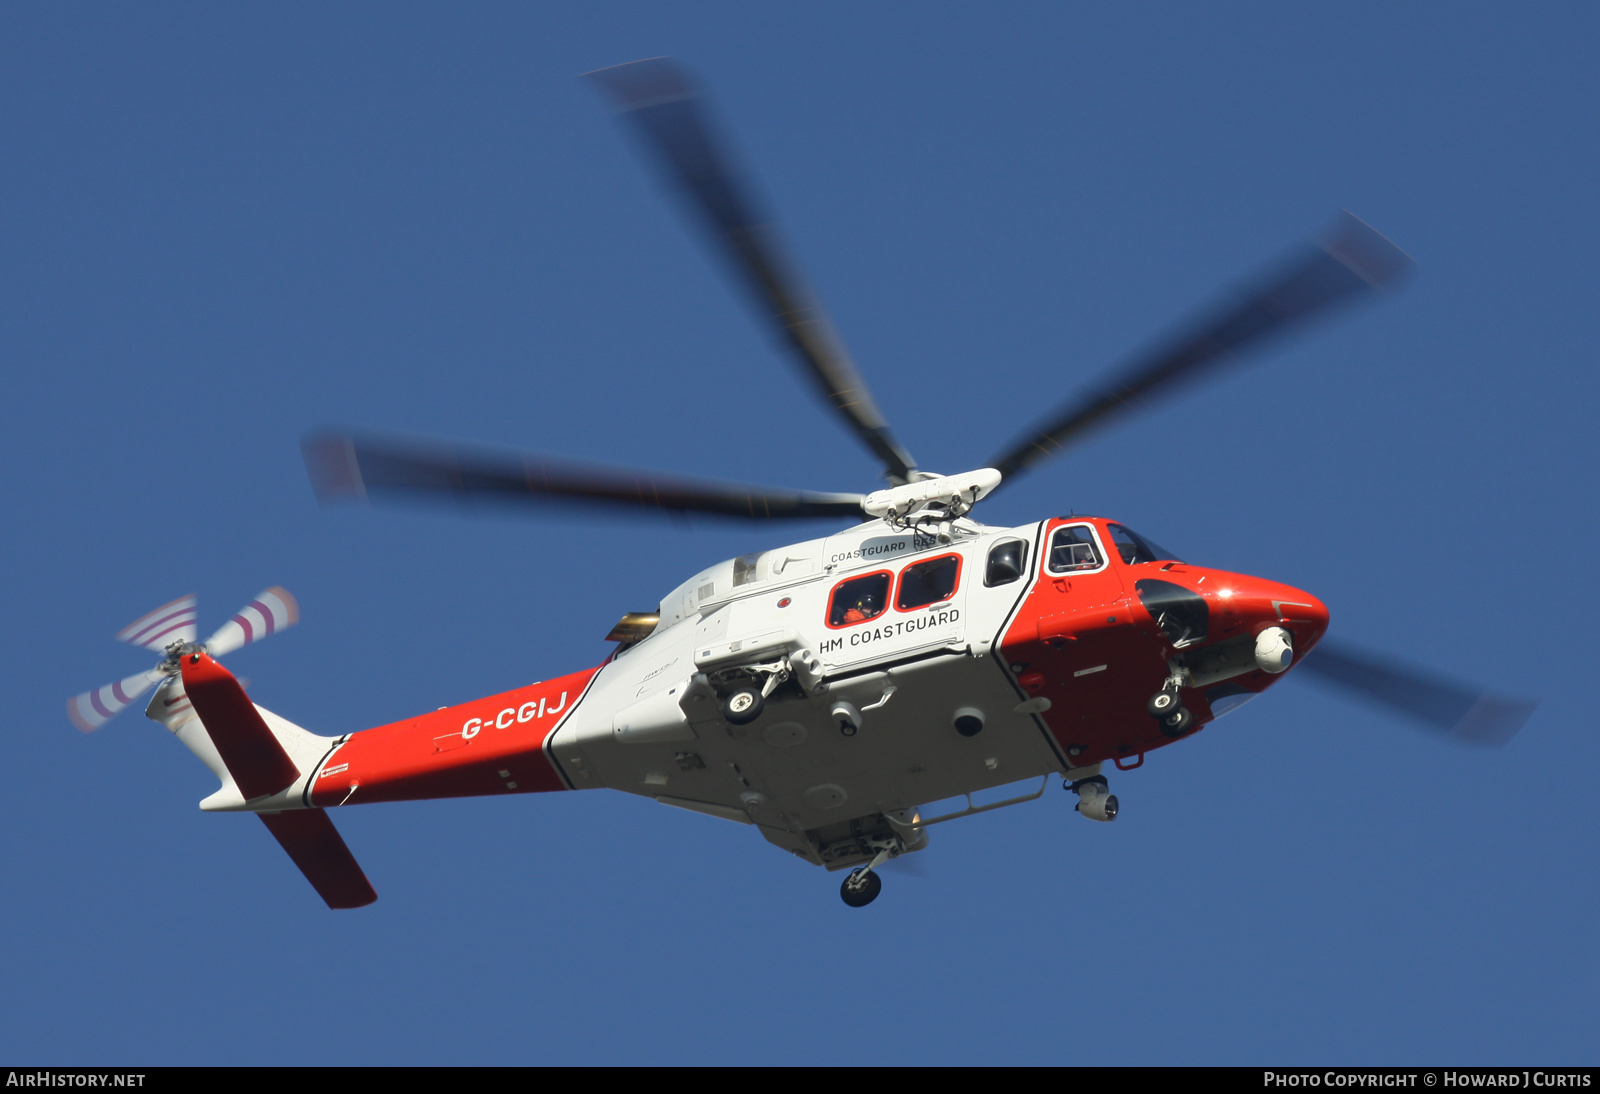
[{"x1": 301, "y1": 433, "x2": 866, "y2": 520}]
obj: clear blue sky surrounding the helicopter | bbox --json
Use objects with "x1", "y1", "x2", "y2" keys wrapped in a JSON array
[{"x1": 0, "y1": 3, "x2": 1600, "y2": 1064}]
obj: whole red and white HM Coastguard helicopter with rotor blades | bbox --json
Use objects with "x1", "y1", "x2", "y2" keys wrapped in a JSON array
[{"x1": 69, "y1": 58, "x2": 1533, "y2": 907}]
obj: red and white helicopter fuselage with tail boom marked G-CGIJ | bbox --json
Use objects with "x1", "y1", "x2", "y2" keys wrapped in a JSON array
[{"x1": 306, "y1": 517, "x2": 1328, "y2": 868}]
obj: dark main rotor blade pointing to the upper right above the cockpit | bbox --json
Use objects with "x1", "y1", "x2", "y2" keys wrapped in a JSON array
[{"x1": 989, "y1": 213, "x2": 1411, "y2": 480}]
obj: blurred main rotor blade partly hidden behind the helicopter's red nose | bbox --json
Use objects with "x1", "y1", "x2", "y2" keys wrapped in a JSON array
[{"x1": 1301, "y1": 640, "x2": 1539, "y2": 745}]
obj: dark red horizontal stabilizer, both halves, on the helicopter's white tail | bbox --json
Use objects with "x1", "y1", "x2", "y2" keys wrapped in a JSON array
[{"x1": 182, "y1": 653, "x2": 378, "y2": 908}]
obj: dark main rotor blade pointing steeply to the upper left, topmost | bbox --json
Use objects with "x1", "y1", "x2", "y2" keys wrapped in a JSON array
[{"x1": 589, "y1": 58, "x2": 917, "y2": 485}]
